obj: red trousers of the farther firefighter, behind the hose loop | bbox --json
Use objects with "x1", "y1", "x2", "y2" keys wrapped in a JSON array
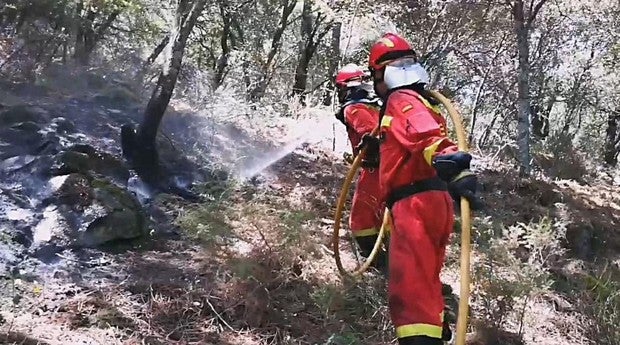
[{"x1": 349, "y1": 169, "x2": 385, "y2": 237}]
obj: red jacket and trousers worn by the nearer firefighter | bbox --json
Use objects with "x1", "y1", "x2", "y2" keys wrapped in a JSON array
[{"x1": 379, "y1": 89, "x2": 457, "y2": 338}]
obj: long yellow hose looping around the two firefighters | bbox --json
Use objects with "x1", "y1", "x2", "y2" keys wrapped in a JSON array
[{"x1": 332, "y1": 91, "x2": 471, "y2": 345}]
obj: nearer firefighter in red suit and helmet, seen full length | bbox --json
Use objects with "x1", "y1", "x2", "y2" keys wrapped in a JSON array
[{"x1": 362, "y1": 33, "x2": 481, "y2": 345}]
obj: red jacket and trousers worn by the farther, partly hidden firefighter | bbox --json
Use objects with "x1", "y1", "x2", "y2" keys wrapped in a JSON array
[{"x1": 344, "y1": 103, "x2": 385, "y2": 239}]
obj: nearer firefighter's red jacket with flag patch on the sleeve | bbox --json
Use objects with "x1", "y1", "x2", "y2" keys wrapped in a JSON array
[{"x1": 379, "y1": 89, "x2": 458, "y2": 200}]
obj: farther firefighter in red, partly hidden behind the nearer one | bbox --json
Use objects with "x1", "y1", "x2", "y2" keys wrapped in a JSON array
[{"x1": 336, "y1": 64, "x2": 387, "y2": 268}]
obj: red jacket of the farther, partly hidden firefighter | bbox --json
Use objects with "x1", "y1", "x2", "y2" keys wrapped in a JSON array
[{"x1": 344, "y1": 103, "x2": 379, "y2": 155}]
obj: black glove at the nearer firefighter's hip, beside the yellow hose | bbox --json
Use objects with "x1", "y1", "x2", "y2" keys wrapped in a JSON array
[{"x1": 433, "y1": 152, "x2": 483, "y2": 210}]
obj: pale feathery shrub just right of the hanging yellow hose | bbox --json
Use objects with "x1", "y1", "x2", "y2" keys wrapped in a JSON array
[{"x1": 472, "y1": 217, "x2": 566, "y2": 344}]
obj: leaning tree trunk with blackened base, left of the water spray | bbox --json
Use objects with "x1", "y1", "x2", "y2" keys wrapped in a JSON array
[{"x1": 133, "y1": 0, "x2": 206, "y2": 166}]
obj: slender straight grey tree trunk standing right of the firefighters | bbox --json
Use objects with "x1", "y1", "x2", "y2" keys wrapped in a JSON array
[{"x1": 512, "y1": 1, "x2": 532, "y2": 175}]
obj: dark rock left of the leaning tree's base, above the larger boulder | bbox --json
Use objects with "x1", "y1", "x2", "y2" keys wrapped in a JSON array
[{"x1": 52, "y1": 145, "x2": 130, "y2": 185}]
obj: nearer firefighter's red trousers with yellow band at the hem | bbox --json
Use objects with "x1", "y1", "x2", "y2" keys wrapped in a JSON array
[{"x1": 388, "y1": 191, "x2": 454, "y2": 338}]
